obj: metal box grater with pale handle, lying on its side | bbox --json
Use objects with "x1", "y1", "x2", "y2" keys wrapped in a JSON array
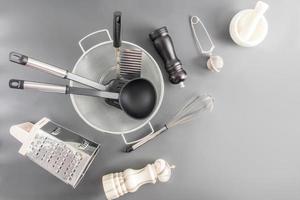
[{"x1": 10, "y1": 118, "x2": 100, "y2": 188}]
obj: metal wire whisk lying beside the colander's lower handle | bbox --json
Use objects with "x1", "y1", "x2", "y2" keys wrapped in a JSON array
[{"x1": 125, "y1": 95, "x2": 214, "y2": 152}]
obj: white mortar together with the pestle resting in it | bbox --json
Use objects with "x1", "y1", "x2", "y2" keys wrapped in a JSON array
[{"x1": 229, "y1": 1, "x2": 269, "y2": 47}]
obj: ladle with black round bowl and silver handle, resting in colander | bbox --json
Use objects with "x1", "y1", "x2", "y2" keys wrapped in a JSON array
[{"x1": 9, "y1": 78, "x2": 156, "y2": 119}]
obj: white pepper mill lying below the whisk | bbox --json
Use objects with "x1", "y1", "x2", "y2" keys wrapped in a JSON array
[{"x1": 102, "y1": 159, "x2": 175, "y2": 200}]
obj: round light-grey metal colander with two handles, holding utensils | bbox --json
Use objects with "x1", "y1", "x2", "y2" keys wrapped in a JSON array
[{"x1": 70, "y1": 30, "x2": 164, "y2": 134}]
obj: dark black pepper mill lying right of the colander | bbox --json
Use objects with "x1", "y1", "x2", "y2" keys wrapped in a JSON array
[{"x1": 149, "y1": 26, "x2": 187, "y2": 87}]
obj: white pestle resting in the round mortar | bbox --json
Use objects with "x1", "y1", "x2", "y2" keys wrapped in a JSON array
[{"x1": 239, "y1": 1, "x2": 269, "y2": 41}]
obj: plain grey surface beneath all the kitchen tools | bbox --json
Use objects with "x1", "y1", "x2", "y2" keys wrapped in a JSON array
[{"x1": 0, "y1": 0, "x2": 300, "y2": 200}]
